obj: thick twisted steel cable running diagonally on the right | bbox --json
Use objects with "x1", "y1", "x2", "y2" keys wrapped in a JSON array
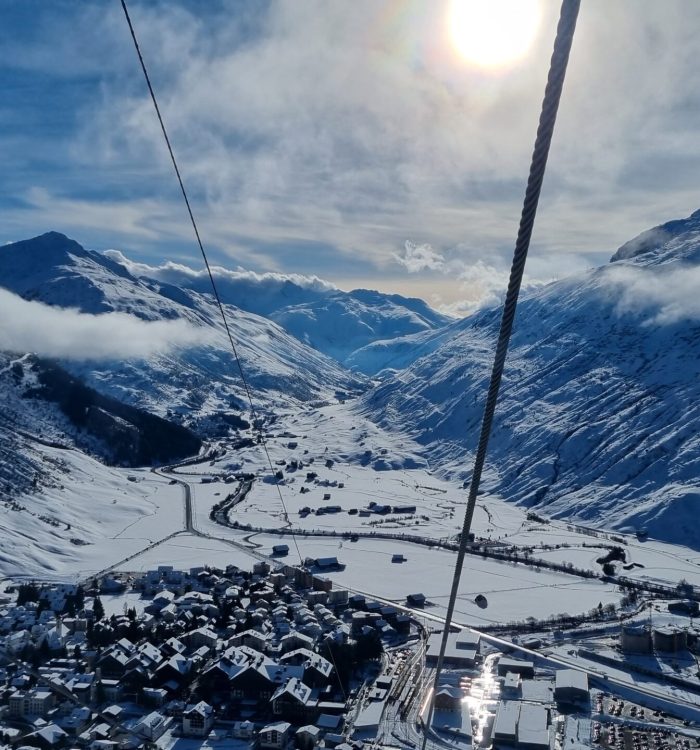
[{"x1": 423, "y1": 0, "x2": 581, "y2": 748}]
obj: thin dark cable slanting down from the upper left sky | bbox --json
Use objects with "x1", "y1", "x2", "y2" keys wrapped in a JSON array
[{"x1": 121, "y1": 0, "x2": 303, "y2": 564}]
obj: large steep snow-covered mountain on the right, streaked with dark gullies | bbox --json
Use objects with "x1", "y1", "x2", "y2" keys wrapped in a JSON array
[{"x1": 363, "y1": 212, "x2": 700, "y2": 547}]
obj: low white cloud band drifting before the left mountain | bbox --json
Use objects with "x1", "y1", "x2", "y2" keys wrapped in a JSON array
[{"x1": 0, "y1": 289, "x2": 213, "y2": 360}]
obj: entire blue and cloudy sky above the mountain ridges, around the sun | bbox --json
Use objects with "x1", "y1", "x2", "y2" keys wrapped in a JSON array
[{"x1": 0, "y1": 0, "x2": 700, "y2": 314}]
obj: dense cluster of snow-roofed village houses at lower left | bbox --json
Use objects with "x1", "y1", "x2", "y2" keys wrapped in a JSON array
[{"x1": 0, "y1": 562, "x2": 411, "y2": 750}]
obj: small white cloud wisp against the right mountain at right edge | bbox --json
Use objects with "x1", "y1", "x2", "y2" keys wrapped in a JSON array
[{"x1": 603, "y1": 264, "x2": 700, "y2": 326}]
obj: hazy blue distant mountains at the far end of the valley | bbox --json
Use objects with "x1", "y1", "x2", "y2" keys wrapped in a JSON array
[{"x1": 107, "y1": 251, "x2": 452, "y2": 374}]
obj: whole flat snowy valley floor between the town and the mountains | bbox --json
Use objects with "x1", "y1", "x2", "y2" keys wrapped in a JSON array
[{"x1": 5, "y1": 404, "x2": 700, "y2": 625}]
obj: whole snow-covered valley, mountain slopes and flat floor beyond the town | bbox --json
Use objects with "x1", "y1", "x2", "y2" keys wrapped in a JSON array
[{"x1": 0, "y1": 215, "x2": 700, "y2": 623}]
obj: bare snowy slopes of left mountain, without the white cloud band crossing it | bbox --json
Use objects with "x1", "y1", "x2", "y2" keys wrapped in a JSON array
[{"x1": 0, "y1": 232, "x2": 362, "y2": 417}]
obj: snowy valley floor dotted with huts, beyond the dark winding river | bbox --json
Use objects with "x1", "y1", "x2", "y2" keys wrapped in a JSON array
[{"x1": 187, "y1": 405, "x2": 700, "y2": 592}]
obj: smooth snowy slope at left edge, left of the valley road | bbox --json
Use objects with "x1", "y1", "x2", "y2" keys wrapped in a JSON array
[{"x1": 0, "y1": 446, "x2": 183, "y2": 580}]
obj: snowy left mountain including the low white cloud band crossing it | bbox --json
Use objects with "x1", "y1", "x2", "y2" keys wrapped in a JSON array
[{"x1": 0, "y1": 232, "x2": 364, "y2": 418}]
